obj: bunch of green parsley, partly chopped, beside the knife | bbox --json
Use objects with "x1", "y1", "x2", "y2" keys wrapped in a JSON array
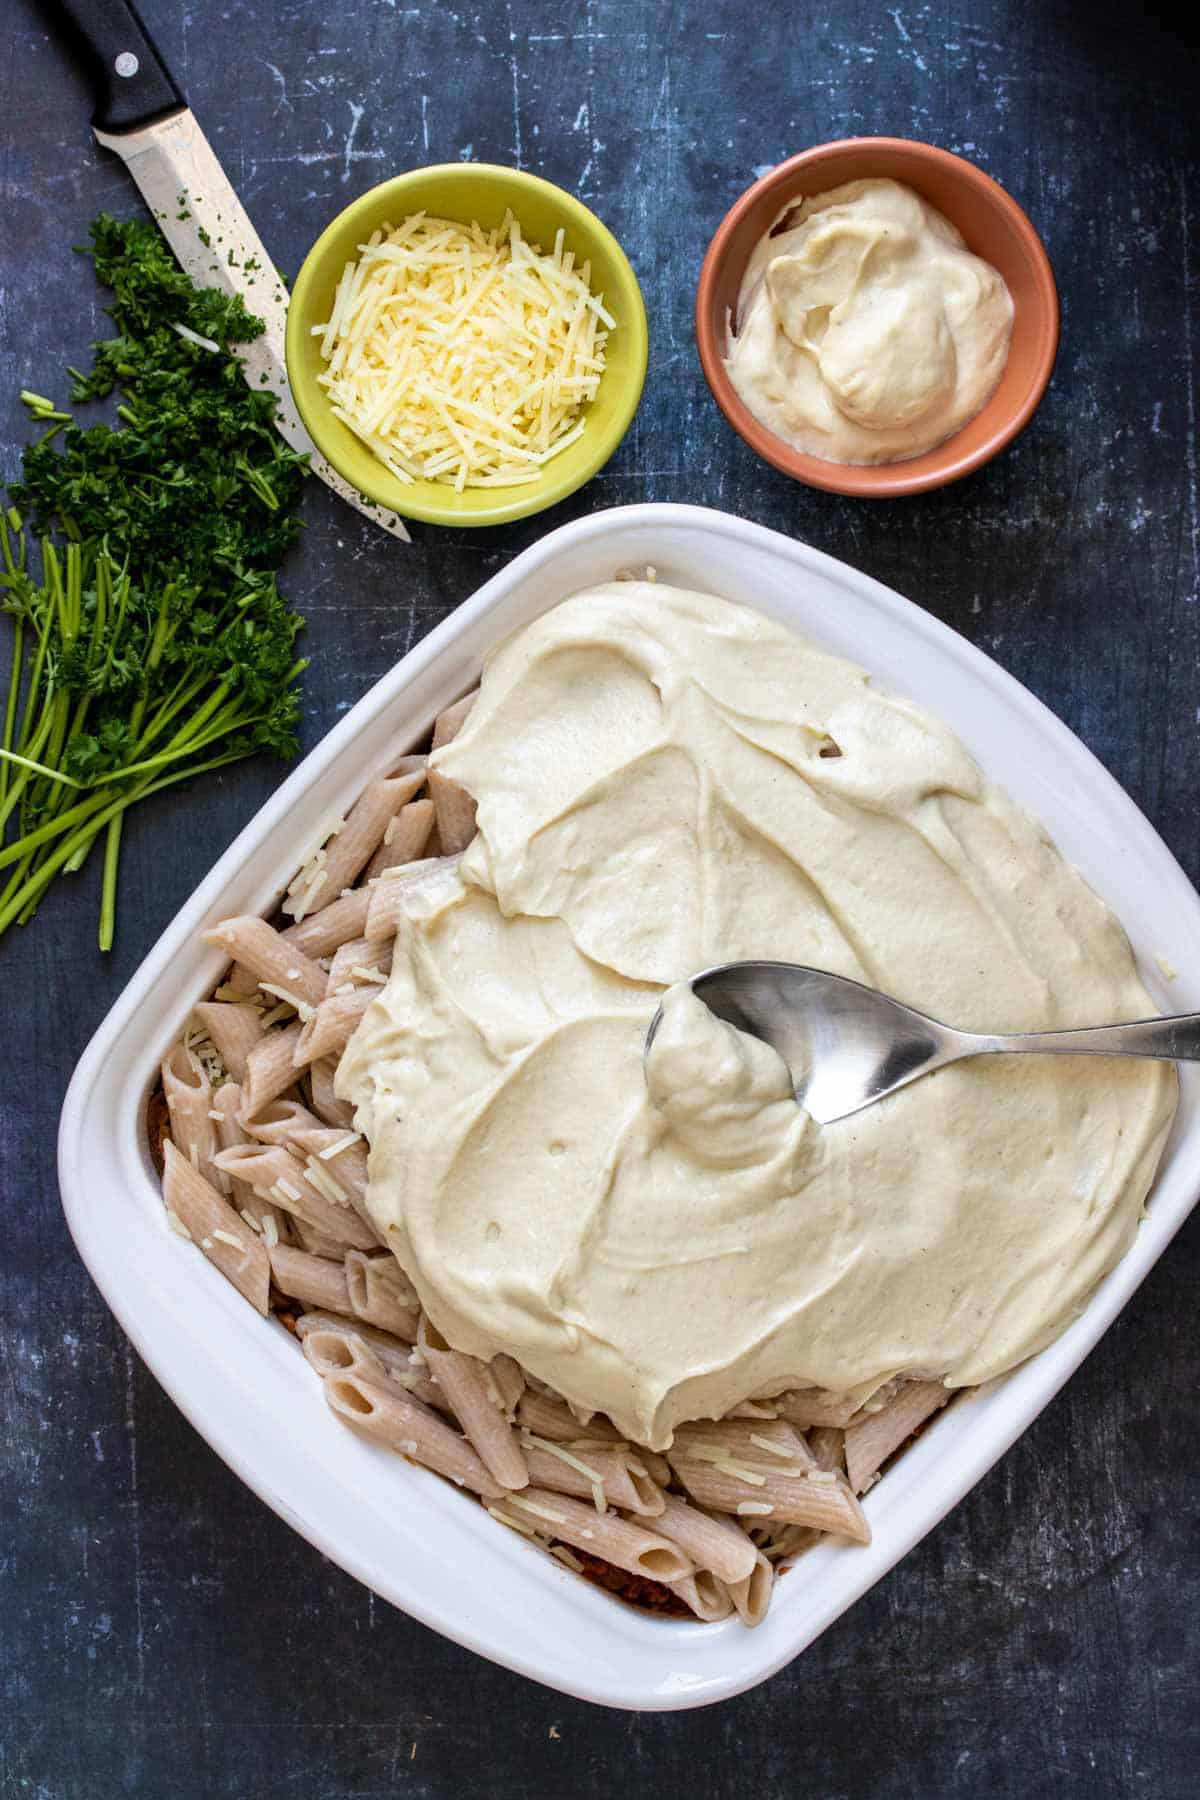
[{"x1": 0, "y1": 214, "x2": 306, "y2": 950}]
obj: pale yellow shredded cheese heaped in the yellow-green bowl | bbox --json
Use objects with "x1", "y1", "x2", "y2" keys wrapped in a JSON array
[{"x1": 313, "y1": 212, "x2": 615, "y2": 489}]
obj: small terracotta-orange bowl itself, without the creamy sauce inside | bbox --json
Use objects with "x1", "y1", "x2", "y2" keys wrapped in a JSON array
[{"x1": 696, "y1": 137, "x2": 1058, "y2": 499}]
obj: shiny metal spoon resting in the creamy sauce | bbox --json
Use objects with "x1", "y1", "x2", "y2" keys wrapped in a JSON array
[{"x1": 646, "y1": 963, "x2": 1200, "y2": 1125}]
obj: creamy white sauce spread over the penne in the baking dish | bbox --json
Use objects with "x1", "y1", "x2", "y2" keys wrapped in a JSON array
[{"x1": 338, "y1": 581, "x2": 1177, "y2": 1445}]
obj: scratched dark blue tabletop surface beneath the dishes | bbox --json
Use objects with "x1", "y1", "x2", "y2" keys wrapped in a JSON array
[{"x1": 0, "y1": 0, "x2": 1200, "y2": 1800}]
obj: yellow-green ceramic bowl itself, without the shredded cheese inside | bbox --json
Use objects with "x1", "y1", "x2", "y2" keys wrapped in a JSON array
[{"x1": 288, "y1": 162, "x2": 648, "y2": 526}]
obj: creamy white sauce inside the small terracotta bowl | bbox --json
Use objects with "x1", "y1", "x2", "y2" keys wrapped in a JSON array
[{"x1": 727, "y1": 180, "x2": 1013, "y2": 463}]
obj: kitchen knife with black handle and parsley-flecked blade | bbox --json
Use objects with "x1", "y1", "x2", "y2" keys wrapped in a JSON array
[{"x1": 52, "y1": 0, "x2": 408, "y2": 542}]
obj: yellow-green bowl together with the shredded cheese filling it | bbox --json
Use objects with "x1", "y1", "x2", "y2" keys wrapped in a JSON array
[{"x1": 288, "y1": 164, "x2": 648, "y2": 526}]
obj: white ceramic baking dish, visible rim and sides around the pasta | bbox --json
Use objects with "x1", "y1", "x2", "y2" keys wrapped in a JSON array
[{"x1": 59, "y1": 506, "x2": 1200, "y2": 1710}]
